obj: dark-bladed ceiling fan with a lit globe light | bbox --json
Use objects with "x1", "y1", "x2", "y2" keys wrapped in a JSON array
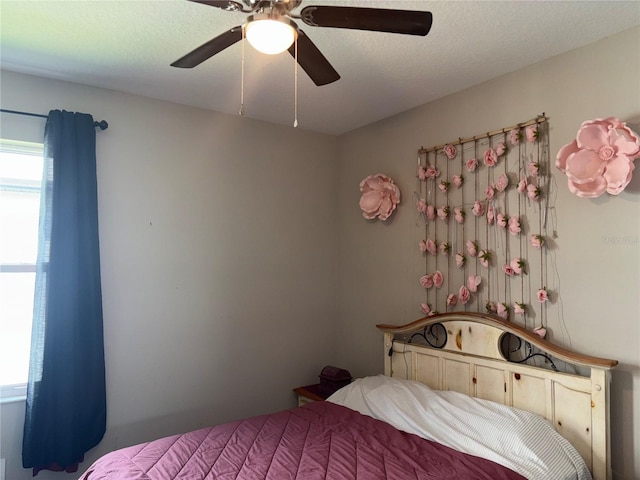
[{"x1": 171, "y1": 0, "x2": 433, "y2": 86}]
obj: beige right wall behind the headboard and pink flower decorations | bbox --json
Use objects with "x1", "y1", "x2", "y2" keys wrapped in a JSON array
[{"x1": 337, "y1": 28, "x2": 640, "y2": 480}]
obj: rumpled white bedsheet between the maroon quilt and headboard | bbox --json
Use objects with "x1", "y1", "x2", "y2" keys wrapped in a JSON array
[{"x1": 328, "y1": 375, "x2": 591, "y2": 480}]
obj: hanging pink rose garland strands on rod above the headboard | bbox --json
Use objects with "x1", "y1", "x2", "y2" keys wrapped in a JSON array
[{"x1": 416, "y1": 115, "x2": 552, "y2": 336}]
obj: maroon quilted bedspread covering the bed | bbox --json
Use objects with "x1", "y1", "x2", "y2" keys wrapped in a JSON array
[{"x1": 81, "y1": 402, "x2": 524, "y2": 480}]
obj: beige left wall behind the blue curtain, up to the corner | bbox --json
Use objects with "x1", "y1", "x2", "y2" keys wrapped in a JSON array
[{"x1": 0, "y1": 72, "x2": 337, "y2": 480}]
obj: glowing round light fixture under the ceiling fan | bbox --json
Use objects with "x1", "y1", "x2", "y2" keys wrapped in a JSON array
[{"x1": 245, "y1": 14, "x2": 298, "y2": 55}]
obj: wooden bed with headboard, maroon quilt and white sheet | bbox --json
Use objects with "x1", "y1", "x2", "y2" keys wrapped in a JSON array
[{"x1": 81, "y1": 313, "x2": 617, "y2": 480}]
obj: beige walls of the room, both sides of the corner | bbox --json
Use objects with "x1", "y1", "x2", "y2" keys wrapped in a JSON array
[{"x1": 0, "y1": 24, "x2": 640, "y2": 480}]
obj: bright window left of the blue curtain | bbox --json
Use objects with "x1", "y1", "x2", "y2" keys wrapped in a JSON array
[{"x1": 0, "y1": 140, "x2": 43, "y2": 399}]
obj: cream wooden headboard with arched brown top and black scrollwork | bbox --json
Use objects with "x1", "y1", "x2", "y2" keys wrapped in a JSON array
[{"x1": 377, "y1": 312, "x2": 618, "y2": 480}]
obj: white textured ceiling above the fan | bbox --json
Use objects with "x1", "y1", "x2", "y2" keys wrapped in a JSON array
[{"x1": 0, "y1": 0, "x2": 640, "y2": 134}]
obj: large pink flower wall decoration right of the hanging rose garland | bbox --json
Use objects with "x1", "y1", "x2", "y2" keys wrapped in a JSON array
[{"x1": 556, "y1": 117, "x2": 640, "y2": 198}]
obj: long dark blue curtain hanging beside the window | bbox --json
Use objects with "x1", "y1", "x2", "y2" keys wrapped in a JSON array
[{"x1": 22, "y1": 110, "x2": 106, "y2": 475}]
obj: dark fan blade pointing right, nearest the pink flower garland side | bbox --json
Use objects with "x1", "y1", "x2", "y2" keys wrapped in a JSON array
[{"x1": 300, "y1": 5, "x2": 433, "y2": 36}]
